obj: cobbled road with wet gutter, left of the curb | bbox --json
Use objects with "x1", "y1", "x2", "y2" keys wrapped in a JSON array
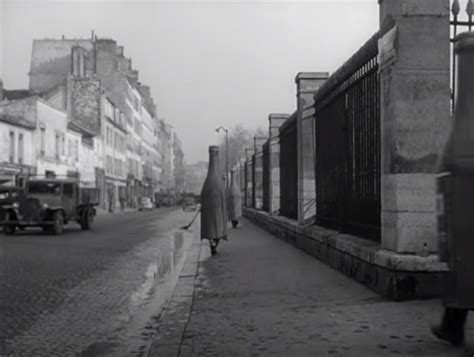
[{"x1": 0, "y1": 208, "x2": 194, "y2": 357}]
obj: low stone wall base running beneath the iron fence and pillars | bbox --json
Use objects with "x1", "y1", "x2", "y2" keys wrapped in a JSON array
[{"x1": 243, "y1": 208, "x2": 448, "y2": 301}]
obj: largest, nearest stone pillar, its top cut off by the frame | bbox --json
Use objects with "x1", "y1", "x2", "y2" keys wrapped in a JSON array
[{"x1": 379, "y1": 0, "x2": 451, "y2": 255}]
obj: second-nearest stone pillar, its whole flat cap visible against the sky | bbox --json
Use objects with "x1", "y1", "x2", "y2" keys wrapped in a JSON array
[{"x1": 295, "y1": 72, "x2": 329, "y2": 224}]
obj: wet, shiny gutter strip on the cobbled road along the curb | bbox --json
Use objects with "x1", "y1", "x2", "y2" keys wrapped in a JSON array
[{"x1": 81, "y1": 231, "x2": 193, "y2": 357}]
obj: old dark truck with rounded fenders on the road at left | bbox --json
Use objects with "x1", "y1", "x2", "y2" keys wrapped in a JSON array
[{"x1": 1, "y1": 178, "x2": 98, "y2": 235}]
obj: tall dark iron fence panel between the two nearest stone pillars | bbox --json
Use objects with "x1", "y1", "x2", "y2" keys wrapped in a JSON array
[{"x1": 315, "y1": 33, "x2": 381, "y2": 240}]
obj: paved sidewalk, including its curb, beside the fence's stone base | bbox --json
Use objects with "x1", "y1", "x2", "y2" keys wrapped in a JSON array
[{"x1": 149, "y1": 220, "x2": 474, "y2": 357}]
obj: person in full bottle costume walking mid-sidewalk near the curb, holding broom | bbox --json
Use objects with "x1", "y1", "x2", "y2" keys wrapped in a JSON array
[{"x1": 201, "y1": 146, "x2": 227, "y2": 255}]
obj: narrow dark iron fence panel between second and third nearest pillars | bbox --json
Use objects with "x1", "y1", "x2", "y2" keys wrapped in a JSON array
[{"x1": 280, "y1": 112, "x2": 298, "y2": 219}]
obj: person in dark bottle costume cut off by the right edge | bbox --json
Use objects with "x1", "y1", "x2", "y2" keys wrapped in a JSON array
[{"x1": 432, "y1": 33, "x2": 474, "y2": 345}]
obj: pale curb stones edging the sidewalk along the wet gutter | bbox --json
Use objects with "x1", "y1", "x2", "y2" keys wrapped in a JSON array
[{"x1": 146, "y1": 223, "x2": 203, "y2": 357}]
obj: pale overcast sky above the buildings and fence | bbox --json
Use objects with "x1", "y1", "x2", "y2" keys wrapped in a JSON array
[{"x1": 0, "y1": 0, "x2": 378, "y2": 163}]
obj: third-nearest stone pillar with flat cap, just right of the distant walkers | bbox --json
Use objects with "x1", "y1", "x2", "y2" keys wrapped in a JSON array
[{"x1": 268, "y1": 113, "x2": 290, "y2": 214}]
